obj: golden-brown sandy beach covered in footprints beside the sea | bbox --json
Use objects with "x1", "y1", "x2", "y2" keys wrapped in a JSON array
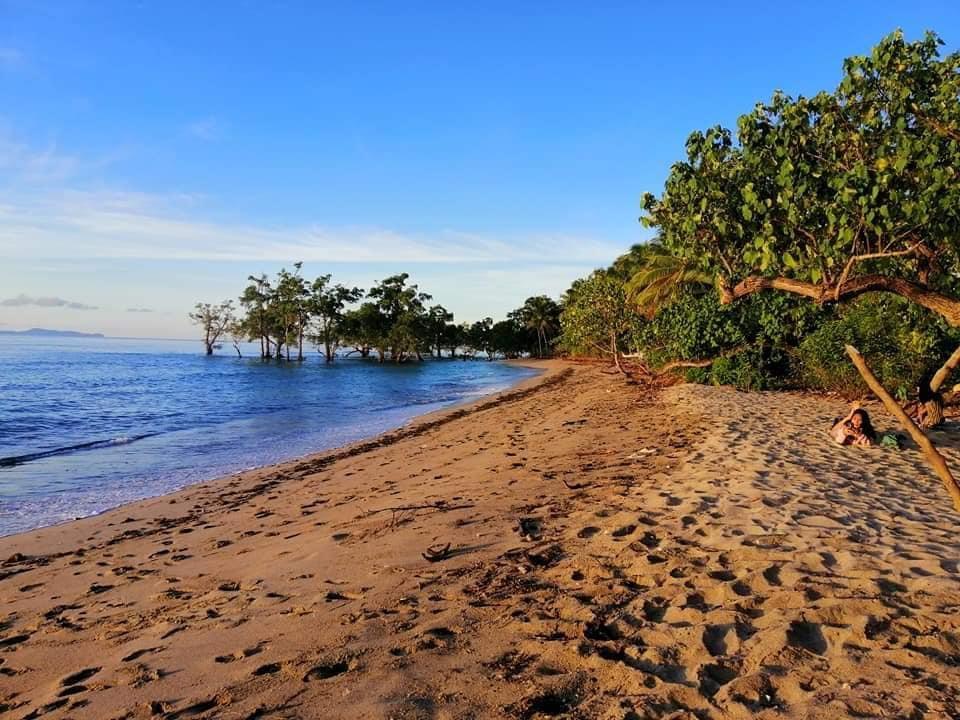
[{"x1": 0, "y1": 362, "x2": 960, "y2": 720}]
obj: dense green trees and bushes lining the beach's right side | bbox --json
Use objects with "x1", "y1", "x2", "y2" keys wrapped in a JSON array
[{"x1": 559, "y1": 33, "x2": 960, "y2": 400}]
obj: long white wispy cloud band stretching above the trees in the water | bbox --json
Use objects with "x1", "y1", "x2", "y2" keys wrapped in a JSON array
[{"x1": 0, "y1": 191, "x2": 622, "y2": 263}]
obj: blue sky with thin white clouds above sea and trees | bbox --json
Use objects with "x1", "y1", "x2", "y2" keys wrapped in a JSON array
[{"x1": 0, "y1": 0, "x2": 960, "y2": 337}]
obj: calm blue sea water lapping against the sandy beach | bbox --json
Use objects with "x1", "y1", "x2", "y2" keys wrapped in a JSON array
[{"x1": 0, "y1": 336, "x2": 533, "y2": 535}]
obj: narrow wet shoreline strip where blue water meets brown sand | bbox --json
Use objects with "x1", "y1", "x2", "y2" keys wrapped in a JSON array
[{"x1": 0, "y1": 359, "x2": 552, "y2": 540}]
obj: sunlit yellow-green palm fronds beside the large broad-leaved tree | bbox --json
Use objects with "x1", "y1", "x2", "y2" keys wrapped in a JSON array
[{"x1": 614, "y1": 240, "x2": 714, "y2": 317}]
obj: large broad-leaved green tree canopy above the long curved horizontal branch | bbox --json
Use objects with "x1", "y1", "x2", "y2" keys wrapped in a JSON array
[{"x1": 643, "y1": 32, "x2": 960, "y2": 326}]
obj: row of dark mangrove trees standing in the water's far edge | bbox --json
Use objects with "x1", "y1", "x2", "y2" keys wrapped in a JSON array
[{"x1": 190, "y1": 263, "x2": 560, "y2": 363}]
